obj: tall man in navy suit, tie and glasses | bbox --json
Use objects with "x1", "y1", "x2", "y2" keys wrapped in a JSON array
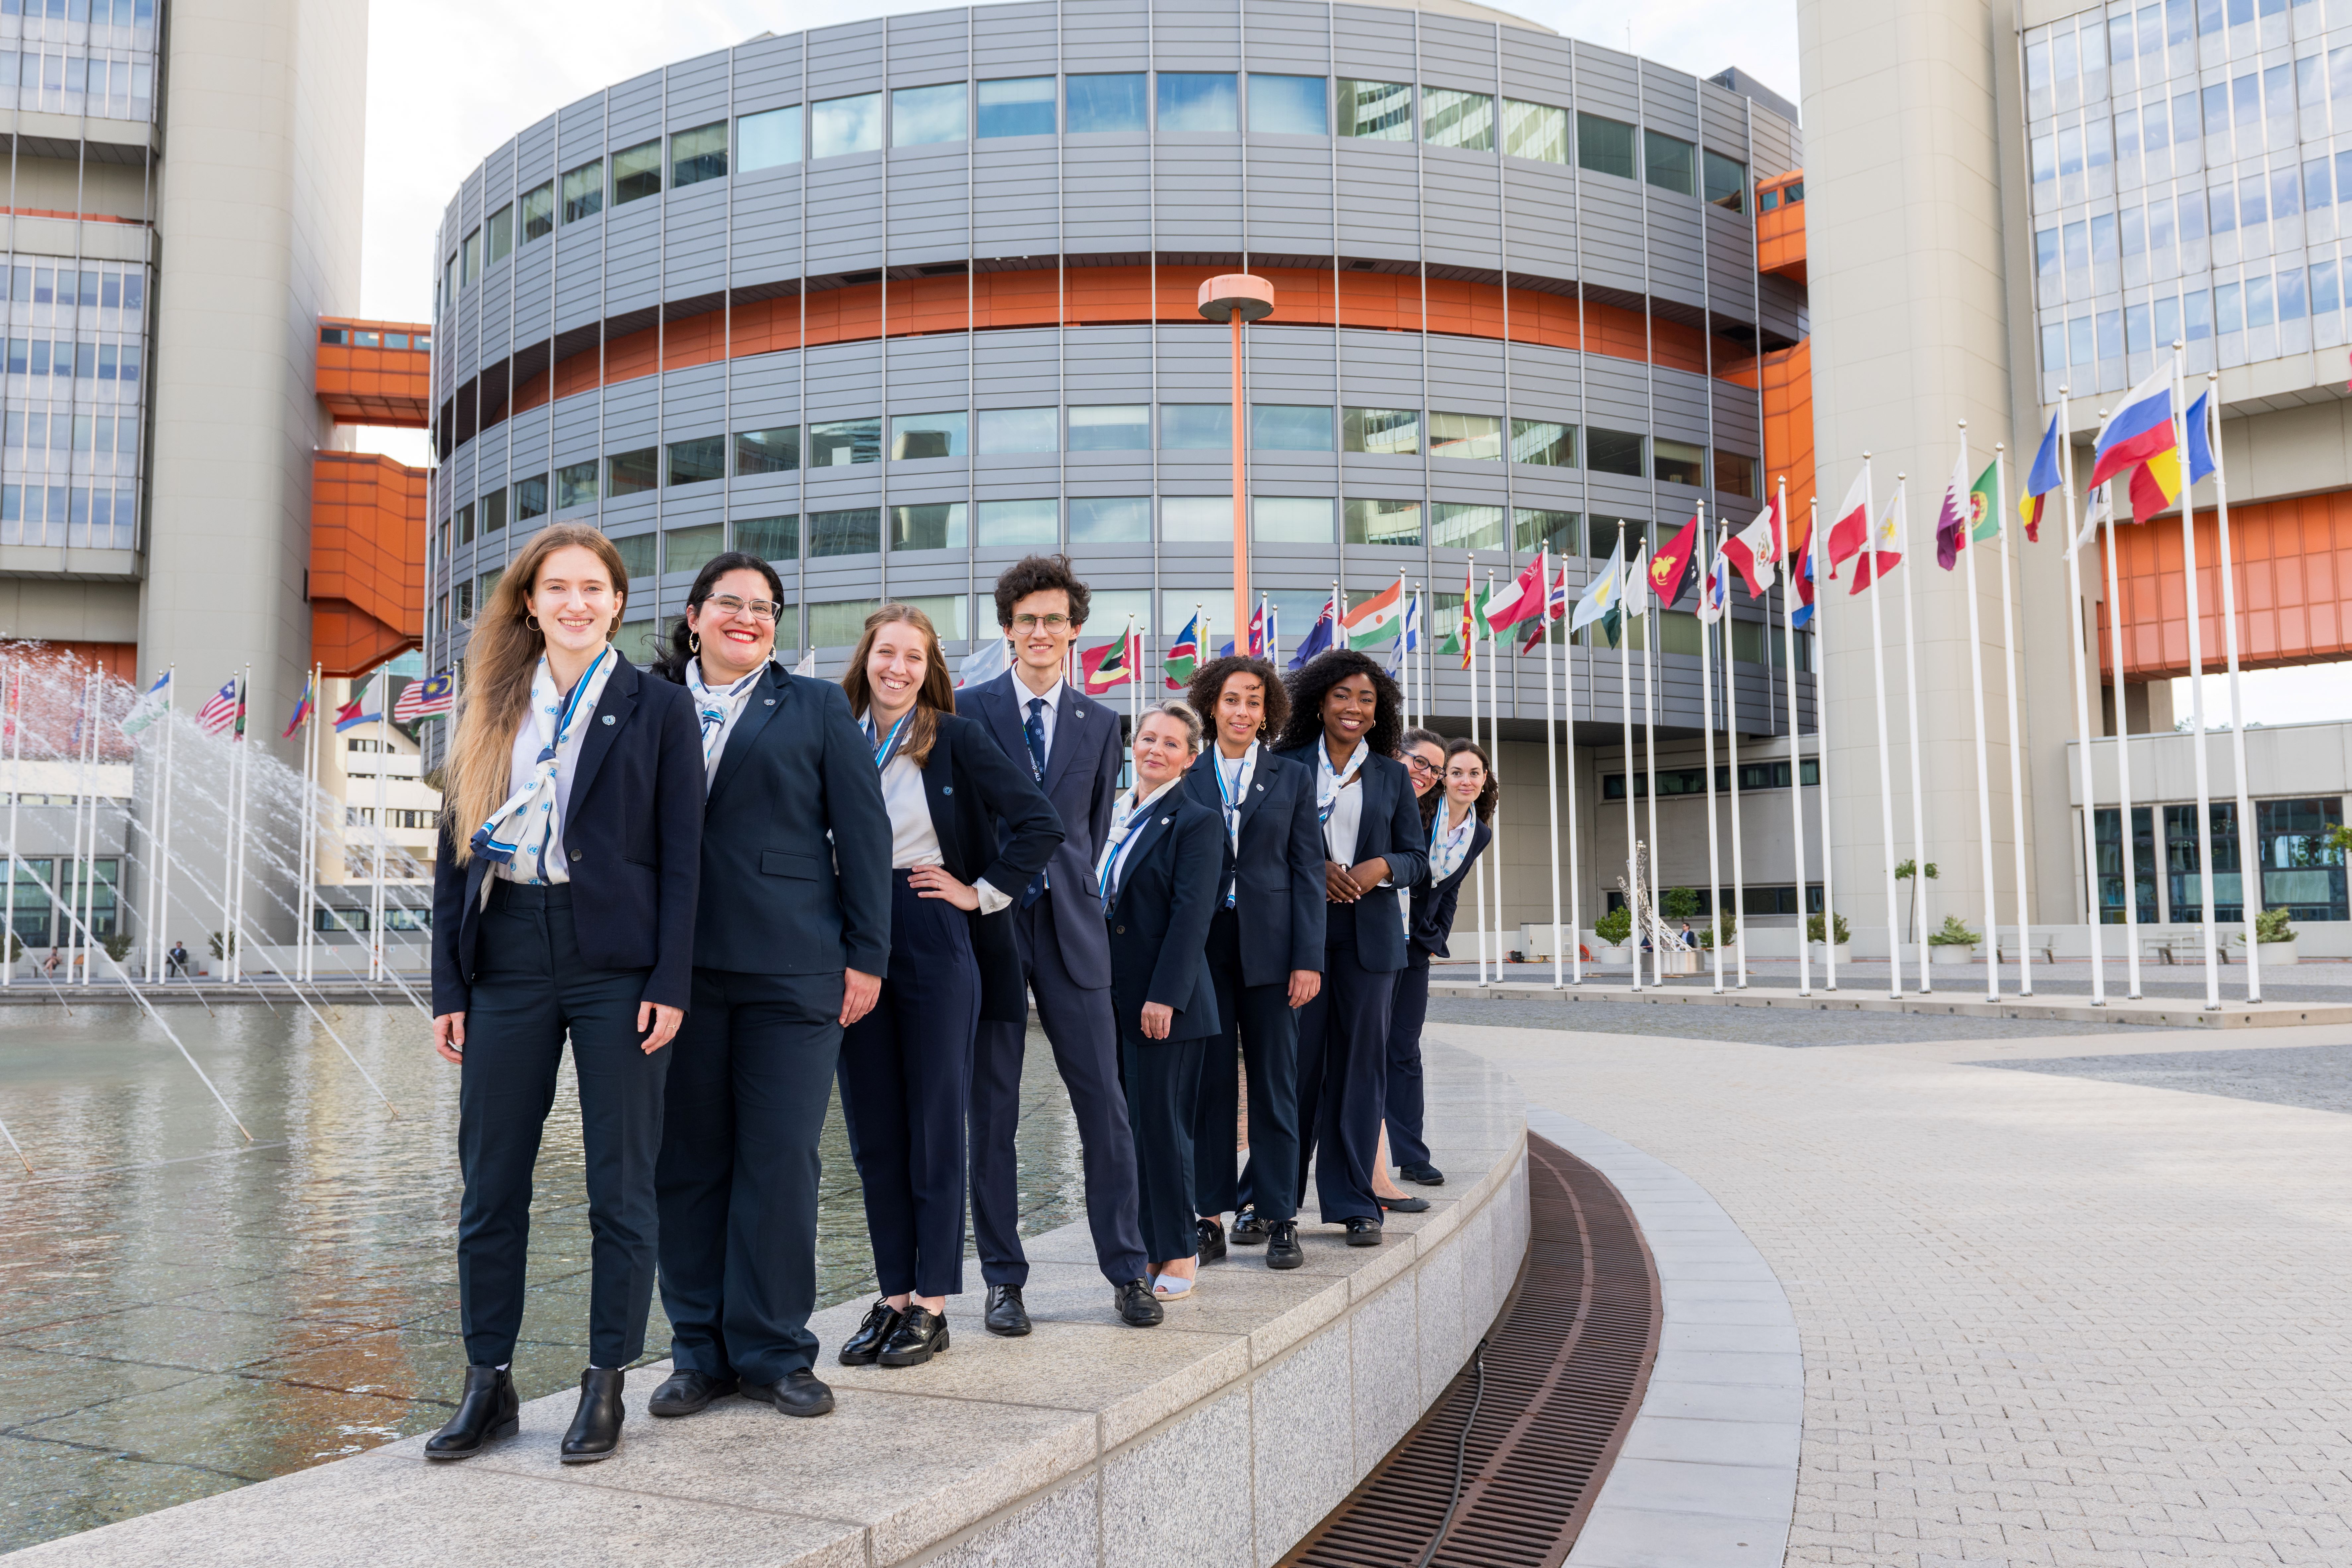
[{"x1": 957, "y1": 555, "x2": 1150, "y2": 1335}]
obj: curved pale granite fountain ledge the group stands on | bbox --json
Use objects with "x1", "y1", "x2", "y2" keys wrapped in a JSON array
[{"x1": 19, "y1": 1044, "x2": 1526, "y2": 1568}]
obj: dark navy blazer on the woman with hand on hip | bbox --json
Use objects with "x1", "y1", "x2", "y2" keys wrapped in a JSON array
[{"x1": 903, "y1": 712, "x2": 1061, "y2": 1023}]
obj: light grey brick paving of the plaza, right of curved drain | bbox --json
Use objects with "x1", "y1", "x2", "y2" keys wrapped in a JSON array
[{"x1": 1430, "y1": 1008, "x2": 2352, "y2": 1568}]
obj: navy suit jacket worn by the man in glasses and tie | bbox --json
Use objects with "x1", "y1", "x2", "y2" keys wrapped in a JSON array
[{"x1": 955, "y1": 670, "x2": 1124, "y2": 990}]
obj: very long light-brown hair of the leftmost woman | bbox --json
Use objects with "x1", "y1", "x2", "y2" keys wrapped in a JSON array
[{"x1": 445, "y1": 522, "x2": 628, "y2": 865}]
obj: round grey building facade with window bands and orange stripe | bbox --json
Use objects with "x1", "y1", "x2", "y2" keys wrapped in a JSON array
[{"x1": 428, "y1": 0, "x2": 1809, "y2": 747}]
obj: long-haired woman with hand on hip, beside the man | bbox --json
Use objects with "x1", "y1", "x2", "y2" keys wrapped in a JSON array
[{"x1": 840, "y1": 604, "x2": 1072, "y2": 1366}]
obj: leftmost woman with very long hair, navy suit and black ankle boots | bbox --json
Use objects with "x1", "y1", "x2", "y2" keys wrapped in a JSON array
[{"x1": 426, "y1": 522, "x2": 703, "y2": 1465}]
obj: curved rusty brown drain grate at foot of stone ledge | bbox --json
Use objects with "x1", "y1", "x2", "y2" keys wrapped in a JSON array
[{"x1": 1282, "y1": 1133, "x2": 1661, "y2": 1568}]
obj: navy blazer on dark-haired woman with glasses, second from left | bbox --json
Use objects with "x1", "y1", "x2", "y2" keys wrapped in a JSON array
[{"x1": 694, "y1": 663, "x2": 891, "y2": 976}]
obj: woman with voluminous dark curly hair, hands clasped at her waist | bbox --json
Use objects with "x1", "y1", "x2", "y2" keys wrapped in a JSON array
[{"x1": 1275, "y1": 649, "x2": 1430, "y2": 1246}]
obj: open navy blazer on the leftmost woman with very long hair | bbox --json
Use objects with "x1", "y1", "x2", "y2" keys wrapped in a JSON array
[{"x1": 433, "y1": 651, "x2": 703, "y2": 1016}]
